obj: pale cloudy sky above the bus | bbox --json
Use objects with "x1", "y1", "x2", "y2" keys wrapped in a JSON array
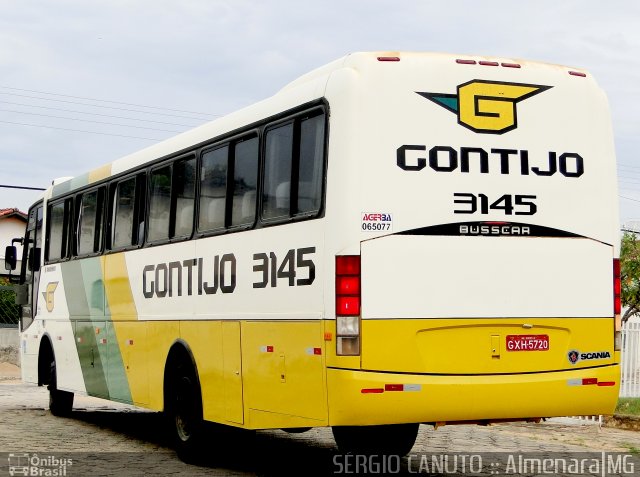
[{"x1": 0, "y1": 0, "x2": 640, "y2": 226}]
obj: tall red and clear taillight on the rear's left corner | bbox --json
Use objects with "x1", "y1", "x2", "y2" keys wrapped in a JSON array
[{"x1": 336, "y1": 255, "x2": 360, "y2": 356}]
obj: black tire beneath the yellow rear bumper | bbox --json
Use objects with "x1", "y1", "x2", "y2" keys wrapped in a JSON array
[{"x1": 332, "y1": 424, "x2": 420, "y2": 457}]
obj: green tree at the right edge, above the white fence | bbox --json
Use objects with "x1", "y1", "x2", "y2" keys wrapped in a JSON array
[{"x1": 620, "y1": 232, "x2": 640, "y2": 323}]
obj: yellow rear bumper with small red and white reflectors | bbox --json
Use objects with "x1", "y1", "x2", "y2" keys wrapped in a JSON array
[{"x1": 327, "y1": 364, "x2": 620, "y2": 426}]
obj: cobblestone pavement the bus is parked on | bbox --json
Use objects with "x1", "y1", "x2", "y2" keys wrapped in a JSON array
[{"x1": 0, "y1": 367, "x2": 640, "y2": 476}]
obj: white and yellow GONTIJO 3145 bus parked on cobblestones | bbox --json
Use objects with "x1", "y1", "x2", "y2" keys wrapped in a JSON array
[{"x1": 7, "y1": 52, "x2": 620, "y2": 458}]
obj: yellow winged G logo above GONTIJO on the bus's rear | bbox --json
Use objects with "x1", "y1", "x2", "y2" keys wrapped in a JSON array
[{"x1": 416, "y1": 80, "x2": 551, "y2": 134}]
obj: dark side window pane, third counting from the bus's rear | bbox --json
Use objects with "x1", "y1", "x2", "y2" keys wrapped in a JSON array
[{"x1": 230, "y1": 137, "x2": 258, "y2": 226}]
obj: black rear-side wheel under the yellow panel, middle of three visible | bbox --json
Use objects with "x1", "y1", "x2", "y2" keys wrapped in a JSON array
[{"x1": 167, "y1": 360, "x2": 205, "y2": 464}]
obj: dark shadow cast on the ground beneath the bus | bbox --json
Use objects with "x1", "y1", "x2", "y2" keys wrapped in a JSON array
[{"x1": 63, "y1": 409, "x2": 443, "y2": 477}]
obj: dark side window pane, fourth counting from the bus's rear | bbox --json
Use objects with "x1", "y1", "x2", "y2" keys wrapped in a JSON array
[{"x1": 198, "y1": 145, "x2": 229, "y2": 232}]
